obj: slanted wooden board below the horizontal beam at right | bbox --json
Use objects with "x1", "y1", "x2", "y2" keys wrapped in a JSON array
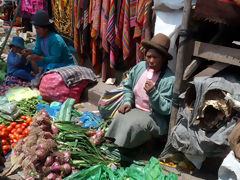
[{"x1": 194, "y1": 62, "x2": 230, "y2": 77}]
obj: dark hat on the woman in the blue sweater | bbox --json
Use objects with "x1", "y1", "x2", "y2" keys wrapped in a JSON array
[{"x1": 31, "y1": 10, "x2": 53, "y2": 26}]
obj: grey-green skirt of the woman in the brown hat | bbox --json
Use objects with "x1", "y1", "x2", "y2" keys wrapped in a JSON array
[{"x1": 106, "y1": 108, "x2": 161, "y2": 148}]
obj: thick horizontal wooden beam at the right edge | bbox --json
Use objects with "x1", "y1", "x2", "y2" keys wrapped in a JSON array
[{"x1": 193, "y1": 41, "x2": 240, "y2": 66}]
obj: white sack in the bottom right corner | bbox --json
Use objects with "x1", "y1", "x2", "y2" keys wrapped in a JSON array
[{"x1": 218, "y1": 151, "x2": 240, "y2": 180}]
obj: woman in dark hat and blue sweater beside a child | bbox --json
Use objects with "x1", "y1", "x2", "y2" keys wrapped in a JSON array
[{"x1": 23, "y1": 10, "x2": 74, "y2": 71}]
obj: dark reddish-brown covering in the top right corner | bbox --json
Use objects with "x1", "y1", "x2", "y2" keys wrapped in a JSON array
[{"x1": 195, "y1": 0, "x2": 240, "y2": 25}]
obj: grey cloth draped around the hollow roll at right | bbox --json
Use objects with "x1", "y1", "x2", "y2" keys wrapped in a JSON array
[{"x1": 161, "y1": 77, "x2": 240, "y2": 168}]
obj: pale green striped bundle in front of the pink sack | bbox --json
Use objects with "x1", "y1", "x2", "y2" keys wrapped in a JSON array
[{"x1": 58, "y1": 98, "x2": 75, "y2": 121}]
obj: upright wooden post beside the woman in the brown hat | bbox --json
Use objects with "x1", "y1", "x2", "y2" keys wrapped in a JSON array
[{"x1": 168, "y1": 0, "x2": 192, "y2": 134}]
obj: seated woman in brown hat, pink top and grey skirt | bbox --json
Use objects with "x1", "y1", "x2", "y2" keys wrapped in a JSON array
[{"x1": 106, "y1": 34, "x2": 175, "y2": 148}]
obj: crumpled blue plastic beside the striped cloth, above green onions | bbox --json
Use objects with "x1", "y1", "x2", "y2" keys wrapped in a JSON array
[{"x1": 78, "y1": 111, "x2": 103, "y2": 128}]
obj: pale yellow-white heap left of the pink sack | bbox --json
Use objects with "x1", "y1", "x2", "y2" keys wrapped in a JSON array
[{"x1": 6, "y1": 87, "x2": 40, "y2": 101}]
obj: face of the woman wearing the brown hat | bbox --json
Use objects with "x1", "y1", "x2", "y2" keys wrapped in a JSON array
[{"x1": 145, "y1": 49, "x2": 167, "y2": 72}]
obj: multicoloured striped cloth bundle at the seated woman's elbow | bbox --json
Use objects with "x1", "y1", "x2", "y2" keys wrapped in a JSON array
[{"x1": 98, "y1": 88, "x2": 123, "y2": 118}]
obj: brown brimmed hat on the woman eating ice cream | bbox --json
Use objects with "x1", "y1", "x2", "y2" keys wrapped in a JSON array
[{"x1": 141, "y1": 33, "x2": 172, "y2": 60}]
